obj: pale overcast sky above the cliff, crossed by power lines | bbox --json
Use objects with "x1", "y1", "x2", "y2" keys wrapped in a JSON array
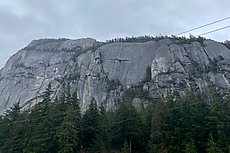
[{"x1": 0, "y1": 0, "x2": 230, "y2": 69}]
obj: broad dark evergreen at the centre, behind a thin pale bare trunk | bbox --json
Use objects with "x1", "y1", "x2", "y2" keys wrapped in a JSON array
[{"x1": 113, "y1": 102, "x2": 145, "y2": 152}]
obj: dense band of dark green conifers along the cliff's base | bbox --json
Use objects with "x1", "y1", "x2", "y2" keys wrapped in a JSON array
[{"x1": 0, "y1": 85, "x2": 230, "y2": 153}]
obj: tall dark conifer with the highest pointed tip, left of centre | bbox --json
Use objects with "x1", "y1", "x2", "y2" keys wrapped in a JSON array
[{"x1": 23, "y1": 83, "x2": 56, "y2": 153}]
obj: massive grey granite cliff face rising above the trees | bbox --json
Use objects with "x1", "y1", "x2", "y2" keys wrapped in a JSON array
[{"x1": 0, "y1": 38, "x2": 230, "y2": 113}]
